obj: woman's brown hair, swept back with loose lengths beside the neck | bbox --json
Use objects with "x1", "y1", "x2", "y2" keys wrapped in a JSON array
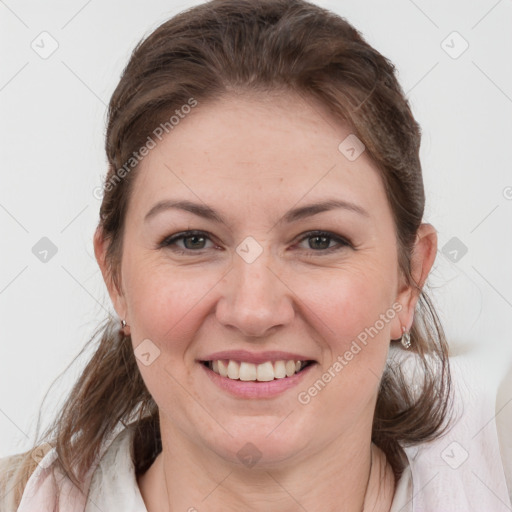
[{"x1": 5, "y1": 0, "x2": 451, "y2": 504}]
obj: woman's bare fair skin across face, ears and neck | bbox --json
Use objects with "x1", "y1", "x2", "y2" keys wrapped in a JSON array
[{"x1": 94, "y1": 94, "x2": 437, "y2": 512}]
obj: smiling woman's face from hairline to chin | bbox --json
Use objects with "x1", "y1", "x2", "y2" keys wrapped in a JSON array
[{"x1": 97, "y1": 91, "x2": 436, "y2": 464}]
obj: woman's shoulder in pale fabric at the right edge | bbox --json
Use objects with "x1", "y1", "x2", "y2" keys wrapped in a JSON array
[{"x1": 405, "y1": 350, "x2": 512, "y2": 512}]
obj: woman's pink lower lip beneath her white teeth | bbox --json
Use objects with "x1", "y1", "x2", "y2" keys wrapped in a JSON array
[{"x1": 198, "y1": 363, "x2": 316, "y2": 398}]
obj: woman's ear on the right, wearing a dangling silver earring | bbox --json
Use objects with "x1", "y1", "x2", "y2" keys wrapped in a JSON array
[{"x1": 391, "y1": 223, "x2": 437, "y2": 340}]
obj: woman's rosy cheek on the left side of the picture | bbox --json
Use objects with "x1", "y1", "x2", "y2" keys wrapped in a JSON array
[{"x1": 126, "y1": 264, "x2": 218, "y2": 412}]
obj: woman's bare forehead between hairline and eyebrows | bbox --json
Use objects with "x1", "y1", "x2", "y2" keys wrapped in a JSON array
[{"x1": 127, "y1": 94, "x2": 389, "y2": 224}]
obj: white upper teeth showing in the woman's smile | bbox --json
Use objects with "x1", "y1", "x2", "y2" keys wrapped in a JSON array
[{"x1": 208, "y1": 359, "x2": 306, "y2": 382}]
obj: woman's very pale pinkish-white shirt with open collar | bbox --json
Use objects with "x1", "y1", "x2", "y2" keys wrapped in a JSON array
[{"x1": 4, "y1": 350, "x2": 512, "y2": 512}]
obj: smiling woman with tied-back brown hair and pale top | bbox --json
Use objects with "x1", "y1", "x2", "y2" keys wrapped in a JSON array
[{"x1": 2, "y1": 0, "x2": 510, "y2": 512}]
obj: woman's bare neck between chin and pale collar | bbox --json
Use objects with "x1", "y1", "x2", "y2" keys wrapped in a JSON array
[{"x1": 138, "y1": 418, "x2": 394, "y2": 512}]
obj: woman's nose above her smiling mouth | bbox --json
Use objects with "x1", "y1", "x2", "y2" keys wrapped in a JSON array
[{"x1": 216, "y1": 251, "x2": 295, "y2": 337}]
